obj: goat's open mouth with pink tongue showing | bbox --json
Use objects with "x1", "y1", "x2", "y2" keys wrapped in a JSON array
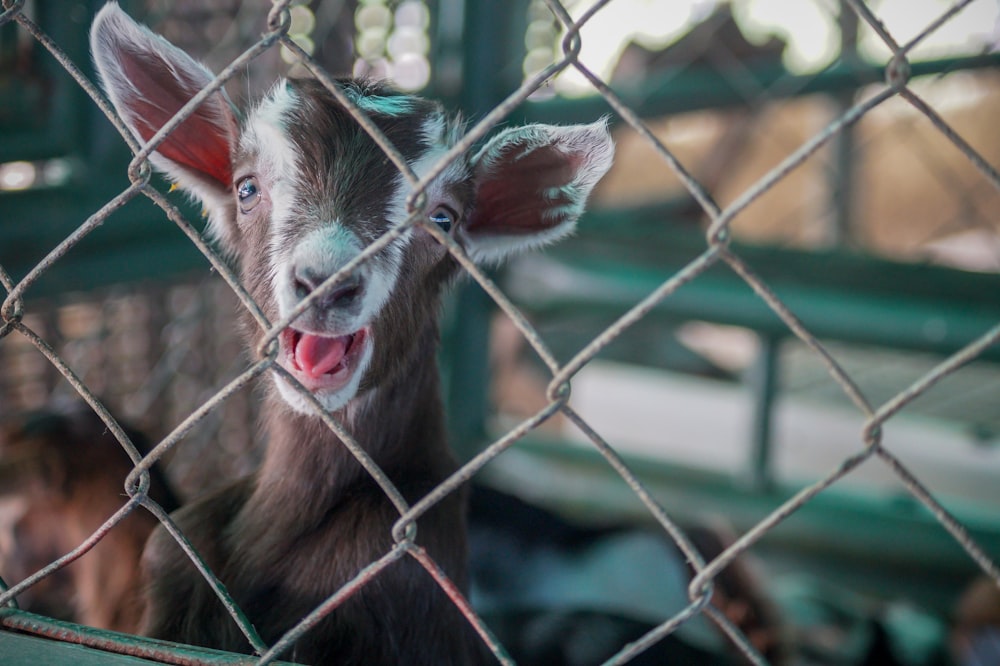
[{"x1": 281, "y1": 328, "x2": 368, "y2": 392}]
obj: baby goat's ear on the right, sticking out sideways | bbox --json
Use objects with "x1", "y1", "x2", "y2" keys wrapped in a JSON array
[{"x1": 460, "y1": 120, "x2": 614, "y2": 263}]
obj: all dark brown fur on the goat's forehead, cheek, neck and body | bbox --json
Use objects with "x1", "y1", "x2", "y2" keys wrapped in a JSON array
[{"x1": 138, "y1": 81, "x2": 483, "y2": 666}]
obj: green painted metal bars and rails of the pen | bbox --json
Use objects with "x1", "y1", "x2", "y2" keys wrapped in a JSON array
[{"x1": 0, "y1": 0, "x2": 1000, "y2": 664}]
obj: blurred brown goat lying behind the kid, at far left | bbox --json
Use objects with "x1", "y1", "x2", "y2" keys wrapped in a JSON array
[{"x1": 0, "y1": 407, "x2": 177, "y2": 632}]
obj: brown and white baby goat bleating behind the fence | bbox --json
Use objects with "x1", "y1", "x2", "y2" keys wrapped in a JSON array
[{"x1": 91, "y1": 4, "x2": 613, "y2": 665}]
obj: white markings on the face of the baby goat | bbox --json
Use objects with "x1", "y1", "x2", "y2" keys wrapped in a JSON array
[{"x1": 262, "y1": 105, "x2": 468, "y2": 418}]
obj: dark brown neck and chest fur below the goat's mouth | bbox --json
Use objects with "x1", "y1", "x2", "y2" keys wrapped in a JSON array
[{"x1": 146, "y1": 304, "x2": 482, "y2": 666}]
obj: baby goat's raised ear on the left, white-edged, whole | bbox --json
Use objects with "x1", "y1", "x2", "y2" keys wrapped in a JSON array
[{"x1": 90, "y1": 2, "x2": 237, "y2": 240}]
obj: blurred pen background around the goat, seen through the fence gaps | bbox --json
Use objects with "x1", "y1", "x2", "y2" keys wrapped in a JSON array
[{"x1": 0, "y1": 0, "x2": 1000, "y2": 664}]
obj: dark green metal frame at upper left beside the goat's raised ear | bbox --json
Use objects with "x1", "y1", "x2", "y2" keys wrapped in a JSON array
[{"x1": 0, "y1": 0, "x2": 208, "y2": 298}]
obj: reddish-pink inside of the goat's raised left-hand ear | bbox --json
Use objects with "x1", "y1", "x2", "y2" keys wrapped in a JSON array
[{"x1": 120, "y1": 52, "x2": 233, "y2": 188}]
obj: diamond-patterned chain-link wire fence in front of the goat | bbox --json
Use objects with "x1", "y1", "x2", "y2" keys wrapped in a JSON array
[{"x1": 0, "y1": 0, "x2": 1000, "y2": 664}]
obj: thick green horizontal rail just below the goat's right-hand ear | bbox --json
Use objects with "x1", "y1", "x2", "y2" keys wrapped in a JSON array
[{"x1": 512, "y1": 220, "x2": 1000, "y2": 361}]
